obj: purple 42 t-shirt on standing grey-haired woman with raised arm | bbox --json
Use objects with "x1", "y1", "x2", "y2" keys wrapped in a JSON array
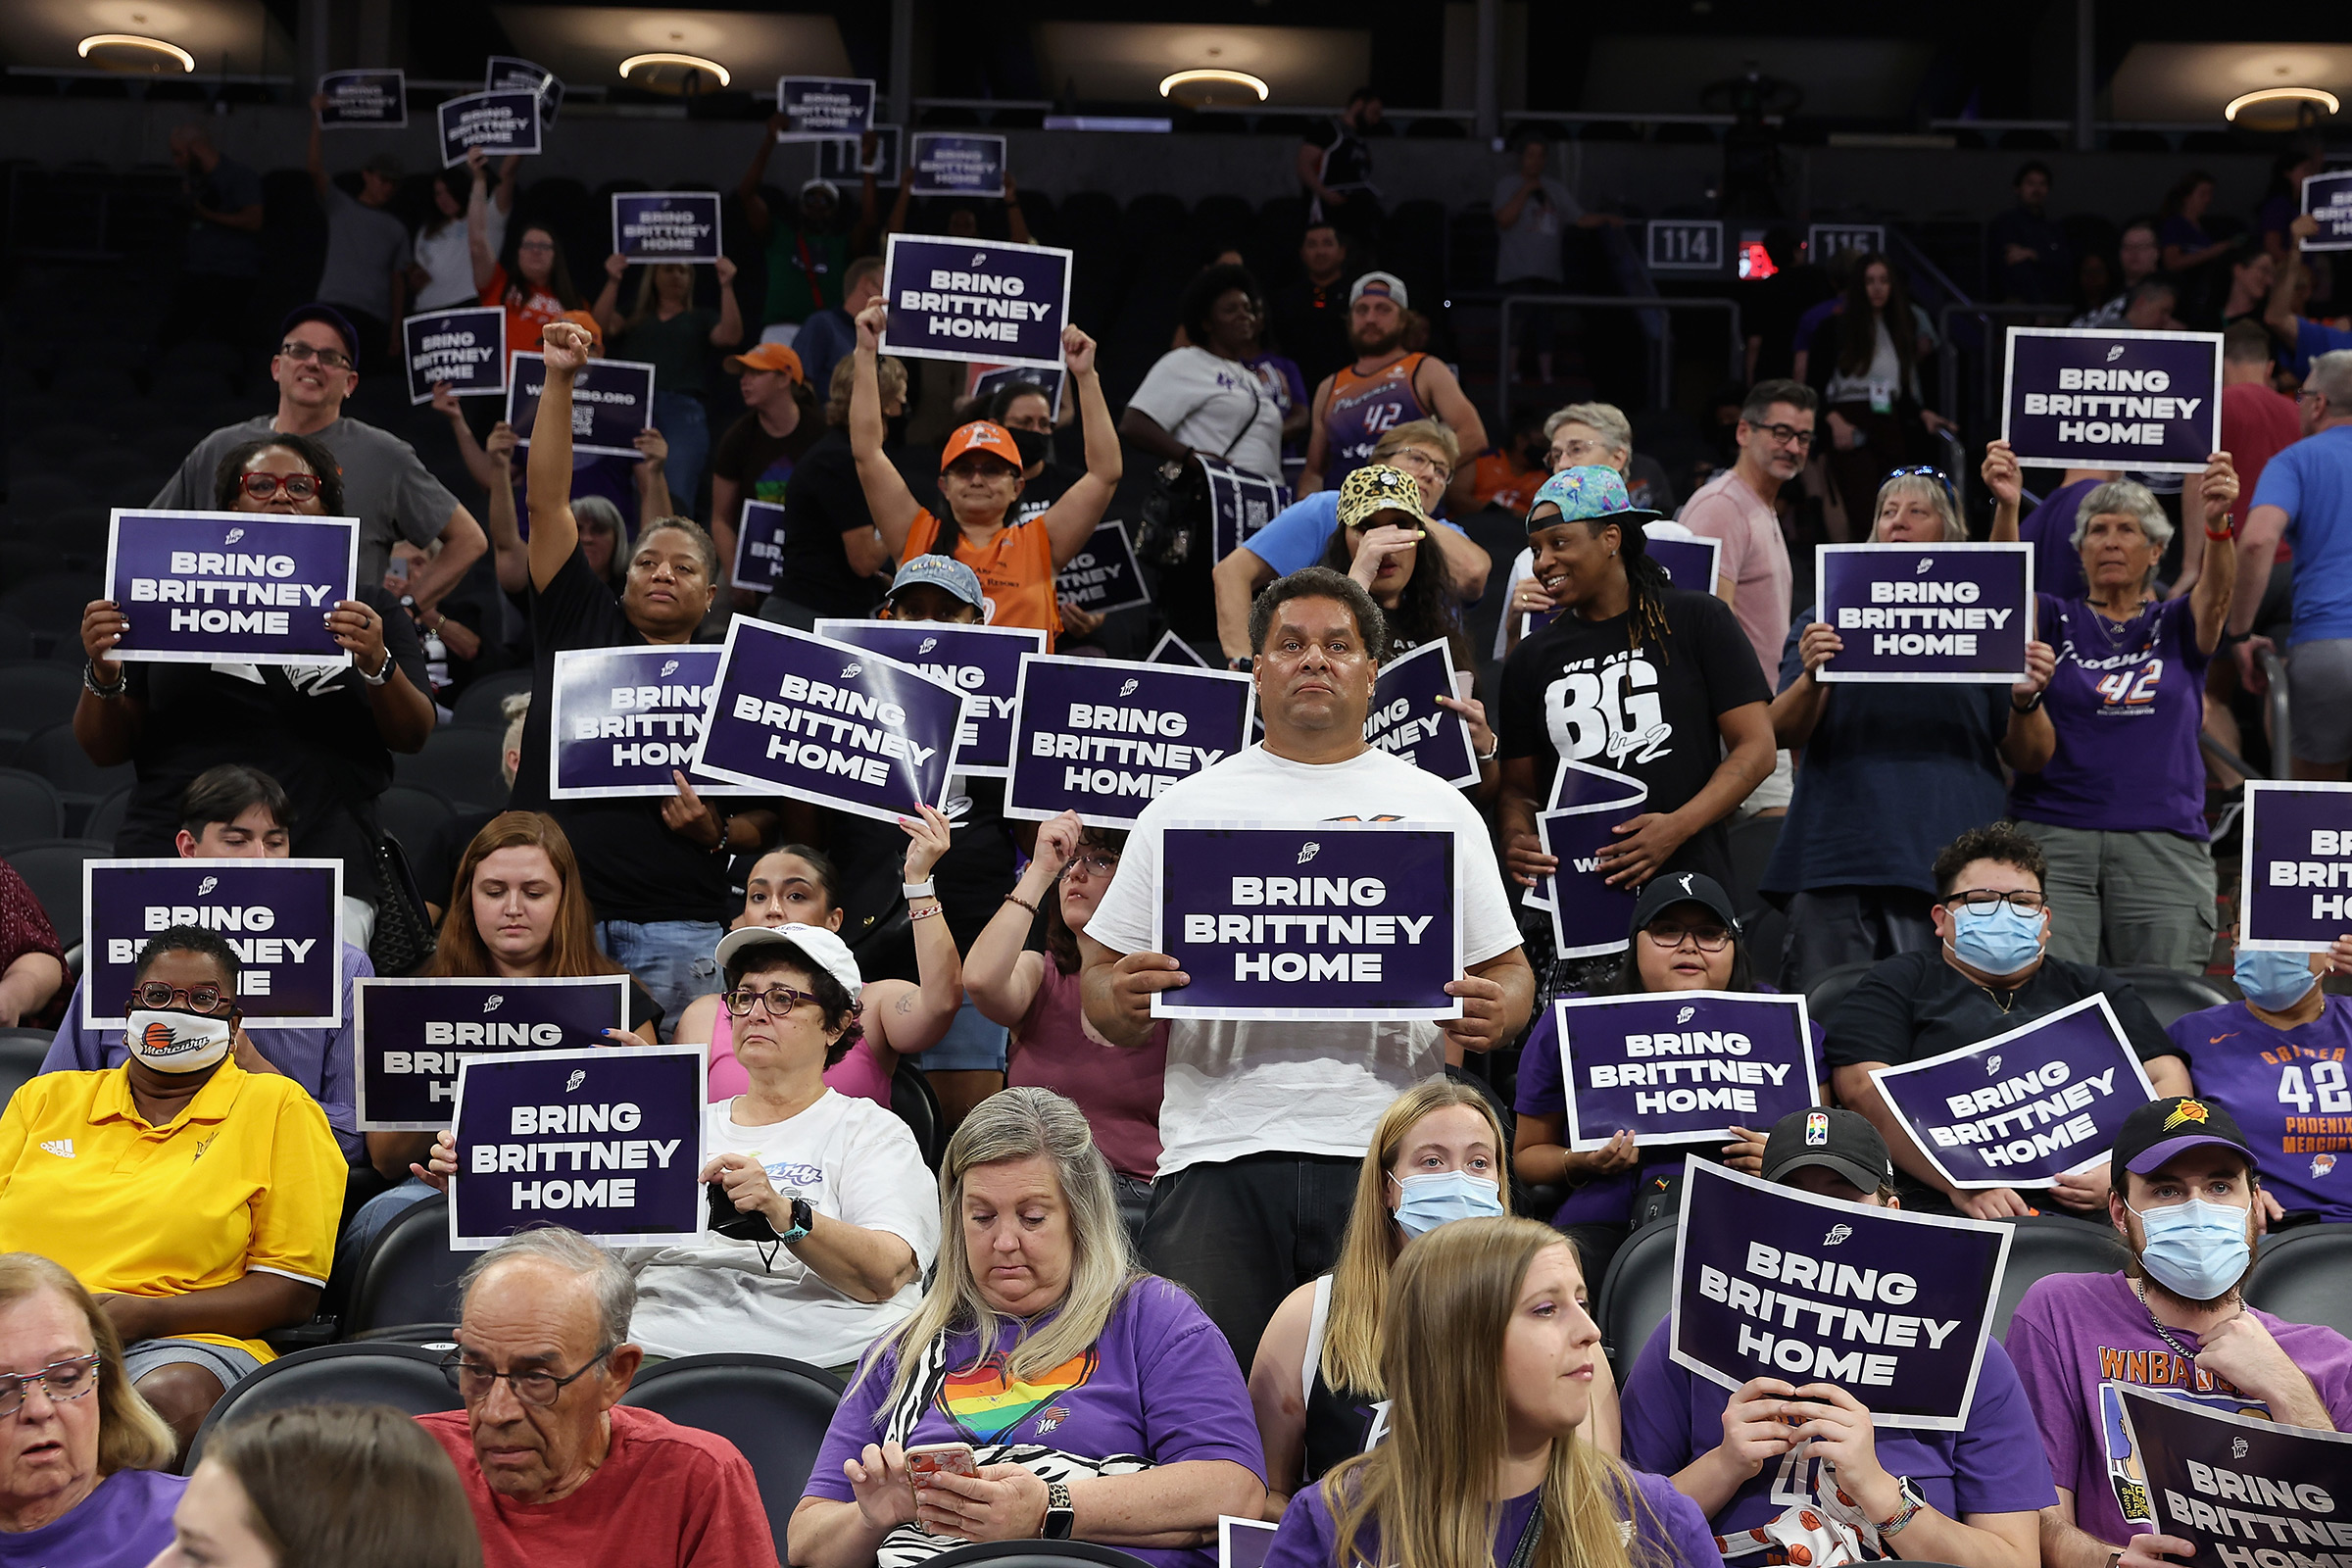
[{"x1": 2009, "y1": 592, "x2": 2211, "y2": 844}]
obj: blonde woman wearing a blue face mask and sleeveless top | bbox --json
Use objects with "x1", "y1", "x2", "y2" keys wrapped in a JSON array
[{"x1": 1249, "y1": 1081, "x2": 1618, "y2": 1519}]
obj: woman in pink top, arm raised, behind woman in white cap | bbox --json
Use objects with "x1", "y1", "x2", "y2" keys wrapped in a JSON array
[{"x1": 677, "y1": 807, "x2": 964, "y2": 1109}]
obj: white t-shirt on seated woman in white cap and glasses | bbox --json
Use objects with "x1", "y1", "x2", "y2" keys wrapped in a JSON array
[{"x1": 628, "y1": 1089, "x2": 939, "y2": 1366}]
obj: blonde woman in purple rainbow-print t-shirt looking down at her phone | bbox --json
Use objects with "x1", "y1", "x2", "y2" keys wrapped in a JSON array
[{"x1": 788, "y1": 1089, "x2": 1265, "y2": 1568}]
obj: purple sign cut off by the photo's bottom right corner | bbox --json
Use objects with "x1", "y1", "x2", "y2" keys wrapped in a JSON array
[{"x1": 2107, "y1": 1382, "x2": 2352, "y2": 1568}]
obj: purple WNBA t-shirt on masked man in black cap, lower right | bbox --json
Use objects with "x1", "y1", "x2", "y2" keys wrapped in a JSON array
[{"x1": 2013, "y1": 1272, "x2": 2352, "y2": 1546}]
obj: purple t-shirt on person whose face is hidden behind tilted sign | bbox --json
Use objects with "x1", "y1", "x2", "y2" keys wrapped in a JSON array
[{"x1": 1618, "y1": 1321, "x2": 2058, "y2": 1535}]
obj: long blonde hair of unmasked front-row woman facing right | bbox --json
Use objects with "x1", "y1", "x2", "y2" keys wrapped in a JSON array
[{"x1": 1322, "y1": 1218, "x2": 1668, "y2": 1568}]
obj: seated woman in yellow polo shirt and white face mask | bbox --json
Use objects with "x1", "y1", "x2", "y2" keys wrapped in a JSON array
[{"x1": 0, "y1": 926, "x2": 348, "y2": 1448}]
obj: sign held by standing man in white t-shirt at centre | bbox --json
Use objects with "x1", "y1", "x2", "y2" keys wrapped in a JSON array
[{"x1": 1152, "y1": 822, "x2": 1463, "y2": 1022}]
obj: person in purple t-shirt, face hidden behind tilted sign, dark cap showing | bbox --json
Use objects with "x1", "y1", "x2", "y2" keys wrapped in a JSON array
[{"x1": 1625, "y1": 1109, "x2": 2058, "y2": 1568}]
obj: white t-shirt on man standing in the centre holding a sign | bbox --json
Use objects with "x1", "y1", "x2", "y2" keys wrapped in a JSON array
[{"x1": 1087, "y1": 745, "x2": 1519, "y2": 1175}]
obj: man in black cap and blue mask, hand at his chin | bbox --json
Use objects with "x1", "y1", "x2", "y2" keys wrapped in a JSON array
[{"x1": 2009, "y1": 1098, "x2": 2352, "y2": 1568}]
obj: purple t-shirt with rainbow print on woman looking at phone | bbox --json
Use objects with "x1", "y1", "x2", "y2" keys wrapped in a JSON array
[{"x1": 807, "y1": 1274, "x2": 1265, "y2": 1568}]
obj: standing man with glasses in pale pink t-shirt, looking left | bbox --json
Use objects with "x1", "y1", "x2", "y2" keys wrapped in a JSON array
[{"x1": 1675, "y1": 381, "x2": 1815, "y2": 815}]
